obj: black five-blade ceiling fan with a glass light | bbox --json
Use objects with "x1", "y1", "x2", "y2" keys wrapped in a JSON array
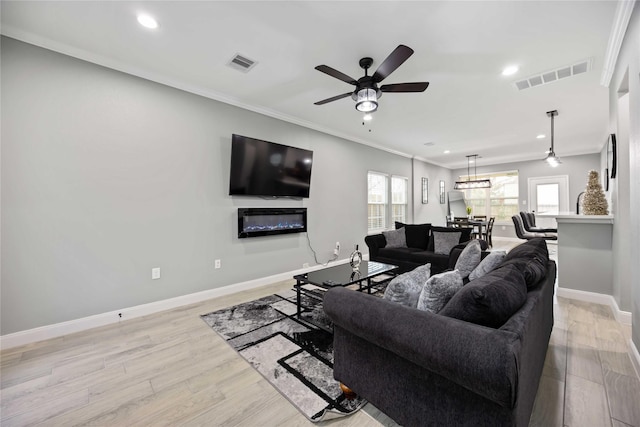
[{"x1": 314, "y1": 44, "x2": 429, "y2": 113}]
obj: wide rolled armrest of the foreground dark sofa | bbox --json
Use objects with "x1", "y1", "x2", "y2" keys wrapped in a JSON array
[{"x1": 324, "y1": 287, "x2": 520, "y2": 408}]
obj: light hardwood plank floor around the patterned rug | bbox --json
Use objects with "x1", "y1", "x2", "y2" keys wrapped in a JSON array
[{"x1": 0, "y1": 242, "x2": 640, "y2": 427}]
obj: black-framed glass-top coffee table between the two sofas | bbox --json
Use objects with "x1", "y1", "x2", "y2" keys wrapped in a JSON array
[{"x1": 293, "y1": 261, "x2": 398, "y2": 332}]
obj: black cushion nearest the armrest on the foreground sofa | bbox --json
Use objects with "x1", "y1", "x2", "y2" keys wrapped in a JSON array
[{"x1": 439, "y1": 265, "x2": 527, "y2": 328}]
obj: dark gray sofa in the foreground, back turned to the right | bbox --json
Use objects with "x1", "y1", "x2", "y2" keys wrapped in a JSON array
[{"x1": 324, "y1": 239, "x2": 556, "y2": 427}]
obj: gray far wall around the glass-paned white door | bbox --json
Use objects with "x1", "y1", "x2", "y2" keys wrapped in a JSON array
[{"x1": 452, "y1": 155, "x2": 601, "y2": 238}]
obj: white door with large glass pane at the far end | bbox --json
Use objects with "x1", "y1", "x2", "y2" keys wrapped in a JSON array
[{"x1": 528, "y1": 175, "x2": 571, "y2": 228}]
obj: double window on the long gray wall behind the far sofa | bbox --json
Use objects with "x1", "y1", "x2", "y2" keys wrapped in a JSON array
[{"x1": 367, "y1": 172, "x2": 409, "y2": 234}]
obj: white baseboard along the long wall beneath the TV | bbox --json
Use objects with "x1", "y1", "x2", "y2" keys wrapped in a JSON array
[{"x1": 0, "y1": 256, "x2": 350, "y2": 350}]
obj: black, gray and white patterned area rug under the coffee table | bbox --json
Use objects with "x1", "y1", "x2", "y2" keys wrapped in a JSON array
[{"x1": 201, "y1": 285, "x2": 384, "y2": 422}]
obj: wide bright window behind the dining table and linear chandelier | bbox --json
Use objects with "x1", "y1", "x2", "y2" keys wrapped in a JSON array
[{"x1": 460, "y1": 171, "x2": 519, "y2": 222}]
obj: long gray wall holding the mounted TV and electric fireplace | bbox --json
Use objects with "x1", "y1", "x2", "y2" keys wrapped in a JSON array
[{"x1": 1, "y1": 38, "x2": 422, "y2": 335}]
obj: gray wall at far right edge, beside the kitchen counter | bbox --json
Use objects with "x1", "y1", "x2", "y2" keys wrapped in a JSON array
[{"x1": 609, "y1": 3, "x2": 640, "y2": 342}]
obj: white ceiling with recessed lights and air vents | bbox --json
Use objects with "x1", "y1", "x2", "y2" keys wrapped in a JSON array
[{"x1": 0, "y1": 0, "x2": 616, "y2": 168}]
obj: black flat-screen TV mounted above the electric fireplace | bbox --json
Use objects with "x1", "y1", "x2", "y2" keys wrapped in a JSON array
[{"x1": 229, "y1": 134, "x2": 313, "y2": 197}]
